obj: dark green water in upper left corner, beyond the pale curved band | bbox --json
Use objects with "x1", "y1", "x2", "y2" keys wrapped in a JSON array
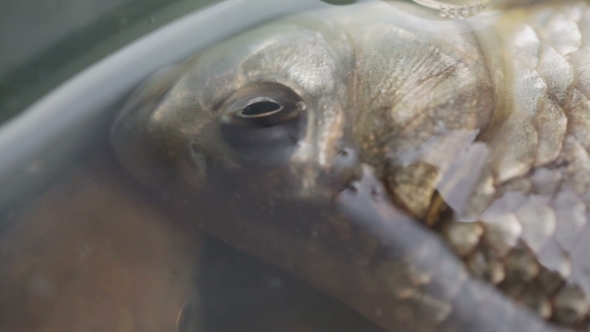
[{"x1": 0, "y1": 0, "x2": 220, "y2": 123}]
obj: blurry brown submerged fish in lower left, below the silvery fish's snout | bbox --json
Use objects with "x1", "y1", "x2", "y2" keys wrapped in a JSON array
[{"x1": 0, "y1": 163, "x2": 200, "y2": 332}]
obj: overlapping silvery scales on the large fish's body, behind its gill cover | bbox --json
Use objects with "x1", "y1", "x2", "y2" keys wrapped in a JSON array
[{"x1": 434, "y1": 3, "x2": 590, "y2": 326}]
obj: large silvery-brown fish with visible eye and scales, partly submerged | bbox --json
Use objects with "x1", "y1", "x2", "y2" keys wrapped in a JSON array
[{"x1": 111, "y1": 0, "x2": 590, "y2": 331}]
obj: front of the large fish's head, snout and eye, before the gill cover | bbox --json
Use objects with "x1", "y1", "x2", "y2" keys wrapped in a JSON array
[{"x1": 111, "y1": 19, "x2": 353, "y2": 202}]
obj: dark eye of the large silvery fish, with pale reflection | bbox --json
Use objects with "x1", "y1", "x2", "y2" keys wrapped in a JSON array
[{"x1": 220, "y1": 84, "x2": 306, "y2": 163}]
